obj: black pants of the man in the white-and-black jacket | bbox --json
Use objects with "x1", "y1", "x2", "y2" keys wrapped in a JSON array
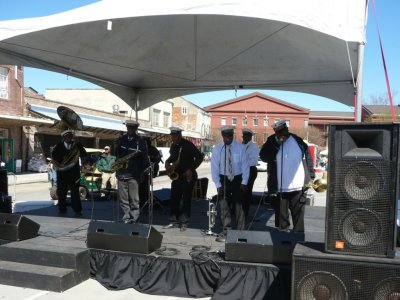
[{"x1": 272, "y1": 190, "x2": 306, "y2": 232}]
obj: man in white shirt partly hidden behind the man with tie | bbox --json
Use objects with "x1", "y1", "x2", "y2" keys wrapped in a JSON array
[{"x1": 242, "y1": 128, "x2": 260, "y2": 218}]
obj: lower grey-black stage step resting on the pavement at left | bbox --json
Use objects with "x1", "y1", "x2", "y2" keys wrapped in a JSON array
[{"x1": 0, "y1": 260, "x2": 82, "y2": 292}]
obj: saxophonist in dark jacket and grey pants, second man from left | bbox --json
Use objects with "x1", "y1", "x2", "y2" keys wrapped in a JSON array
[{"x1": 116, "y1": 120, "x2": 150, "y2": 223}]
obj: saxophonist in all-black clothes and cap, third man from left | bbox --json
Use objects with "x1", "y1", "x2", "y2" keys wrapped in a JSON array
[{"x1": 165, "y1": 127, "x2": 203, "y2": 231}]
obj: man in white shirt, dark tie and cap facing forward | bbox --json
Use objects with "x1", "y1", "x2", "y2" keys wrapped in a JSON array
[{"x1": 211, "y1": 125, "x2": 250, "y2": 241}]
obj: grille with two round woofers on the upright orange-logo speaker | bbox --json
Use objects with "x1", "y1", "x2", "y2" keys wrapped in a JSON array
[{"x1": 326, "y1": 158, "x2": 396, "y2": 256}]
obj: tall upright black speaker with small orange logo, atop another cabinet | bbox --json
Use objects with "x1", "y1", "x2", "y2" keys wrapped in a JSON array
[{"x1": 325, "y1": 123, "x2": 399, "y2": 257}]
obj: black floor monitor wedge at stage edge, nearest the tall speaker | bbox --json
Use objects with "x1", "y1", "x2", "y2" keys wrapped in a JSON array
[{"x1": 225, "y1": 230, "x2": 304, "y2": 264}]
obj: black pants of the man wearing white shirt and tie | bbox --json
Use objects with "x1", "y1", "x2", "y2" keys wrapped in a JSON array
[{"x1": 220, "y1": 175, "x2": 245, "y2": 232}]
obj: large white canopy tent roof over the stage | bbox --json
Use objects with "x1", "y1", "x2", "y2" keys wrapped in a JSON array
[{"x1": 0, "y1": 0, "x2": 368, "y2": 119}]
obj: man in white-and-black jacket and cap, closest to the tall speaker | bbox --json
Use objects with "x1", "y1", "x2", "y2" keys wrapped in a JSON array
[{"x1": 260, "y1": 120, "x2": 315, "y2": 232}]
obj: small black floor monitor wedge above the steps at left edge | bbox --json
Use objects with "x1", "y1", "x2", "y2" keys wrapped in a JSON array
[{"x1": 0, "y1": 213, "x2": 40, "y2": 241}]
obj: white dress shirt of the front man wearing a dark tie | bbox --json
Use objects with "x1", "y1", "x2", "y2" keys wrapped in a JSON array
[{"x1": 211, "y1": 140, "x2": 250, "y2": 188}]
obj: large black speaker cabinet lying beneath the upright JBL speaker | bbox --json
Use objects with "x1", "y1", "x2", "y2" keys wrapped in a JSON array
[{"x1": 291, "y1": 243, "x2": 400, "y2": 300}]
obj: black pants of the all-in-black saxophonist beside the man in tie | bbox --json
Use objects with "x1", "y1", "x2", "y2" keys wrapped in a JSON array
[{"x1": 169, "y1": 172, "x2": 197, "y2": 224}]
